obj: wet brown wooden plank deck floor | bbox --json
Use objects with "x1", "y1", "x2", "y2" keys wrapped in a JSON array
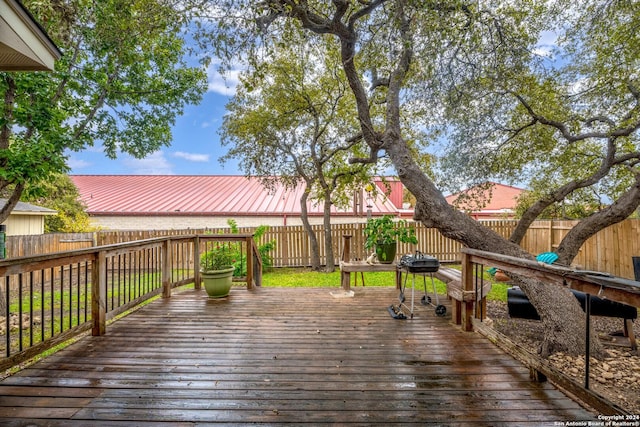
[{"x1": 0, "y1": 287, "x2": 594, "y2": 426}]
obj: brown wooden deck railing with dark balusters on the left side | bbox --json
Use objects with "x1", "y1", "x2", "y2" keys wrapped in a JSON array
[{"x1": 0, "y1": 234, "x2": 262, "y2": 369}]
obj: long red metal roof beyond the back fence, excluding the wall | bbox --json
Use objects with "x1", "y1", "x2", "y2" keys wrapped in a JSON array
[{"x1": 70, "y1": 175, "x2": 398, "y2": 216}]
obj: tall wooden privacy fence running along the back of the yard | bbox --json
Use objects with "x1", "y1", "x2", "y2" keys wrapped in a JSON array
[{"x1": 7, "y1": 219, "x2": 640, "y2": 279}]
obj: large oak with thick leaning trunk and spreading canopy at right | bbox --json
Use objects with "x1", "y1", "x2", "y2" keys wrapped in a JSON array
[{"x1": 198, "y1": 0, "x2": 640, "y2": 354}]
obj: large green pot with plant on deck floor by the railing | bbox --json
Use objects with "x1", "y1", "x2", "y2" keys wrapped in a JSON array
[{"x1": 200, "y1": 243, "x2": 238, "y2": 298}]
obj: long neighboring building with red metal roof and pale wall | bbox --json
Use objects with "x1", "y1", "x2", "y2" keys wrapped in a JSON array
[{"x1": 70, "y1": 175, "x2": 413, "y2": 230}]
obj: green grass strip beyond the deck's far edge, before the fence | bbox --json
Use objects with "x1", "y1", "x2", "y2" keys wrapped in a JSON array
[{"x1": 262, "y1": 268, "x2": 509, "y2": 301}]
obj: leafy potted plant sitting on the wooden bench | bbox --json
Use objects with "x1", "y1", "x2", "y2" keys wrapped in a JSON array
[{"x1": 364, "y1": 215, "x2": 418, "y2": 264}]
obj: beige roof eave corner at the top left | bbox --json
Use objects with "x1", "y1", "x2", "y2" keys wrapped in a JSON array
[{"x1": 0, "y1": 0, "x2": 61, "y2": 71}]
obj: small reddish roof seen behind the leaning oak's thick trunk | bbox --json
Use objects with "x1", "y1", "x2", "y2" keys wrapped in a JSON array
[{"x1": 446, "y1": 182, "x2": 526, "y2": 214}]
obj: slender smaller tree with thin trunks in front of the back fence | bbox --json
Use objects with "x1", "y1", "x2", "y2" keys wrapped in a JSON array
[{"x1": 221, "y1": 28, "x2": 380, "y2": 271}]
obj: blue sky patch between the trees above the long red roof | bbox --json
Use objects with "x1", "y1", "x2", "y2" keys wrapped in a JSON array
[{"x1": 68, "y1": 64, "x2": 242, "y2": 175}]
